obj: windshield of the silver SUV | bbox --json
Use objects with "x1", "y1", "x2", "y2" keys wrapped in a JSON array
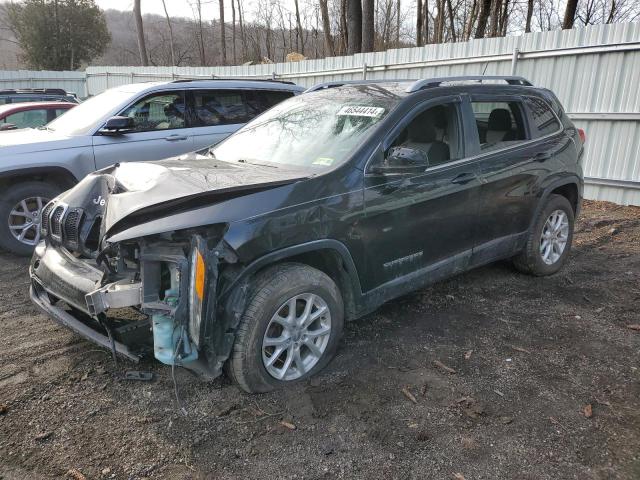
[{"x1": 47, "y1": 89, "x2": 137, "y2": 135}]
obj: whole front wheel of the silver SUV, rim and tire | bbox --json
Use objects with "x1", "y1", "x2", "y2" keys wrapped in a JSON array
[{"x1": 0, "y1": 181, "x2": 62, "y2": 256}]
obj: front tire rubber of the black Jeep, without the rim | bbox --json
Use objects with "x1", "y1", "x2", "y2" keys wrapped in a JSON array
[{"x1": 225, "y1": 263, "x2": 344, "y2": 393}]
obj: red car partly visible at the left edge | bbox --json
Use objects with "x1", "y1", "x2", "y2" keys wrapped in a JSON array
[{"x1": 0, "y1": 102, "x2": 76, "y2": 131}]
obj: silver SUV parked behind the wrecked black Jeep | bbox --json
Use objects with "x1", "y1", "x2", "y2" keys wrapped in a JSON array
[{"x1": 0, "y1": 80, "x2": 304, "y2": 255}]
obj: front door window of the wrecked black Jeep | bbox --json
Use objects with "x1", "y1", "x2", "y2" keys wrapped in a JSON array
[{"x1": 391, "y1": 103, "x2": 462, "y2": 166}]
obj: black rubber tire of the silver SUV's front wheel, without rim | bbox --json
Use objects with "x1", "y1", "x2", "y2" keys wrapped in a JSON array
[{"x1": 0, "y1": 181, "x2": 62, "y2": 256}]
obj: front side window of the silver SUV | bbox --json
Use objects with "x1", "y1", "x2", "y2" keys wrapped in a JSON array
[{"x1": 120, "y1": 91, "x2": 186, "y2": 132}]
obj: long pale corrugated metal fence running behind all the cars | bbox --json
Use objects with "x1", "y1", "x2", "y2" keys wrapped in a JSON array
[{"x1": 0, "y1": 23, "x2": 640, "y2": 205}]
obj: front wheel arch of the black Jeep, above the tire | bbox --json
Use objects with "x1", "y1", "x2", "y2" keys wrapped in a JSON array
[{"x1": 221, "y1": 239, "x2": 362, "y2": 319}]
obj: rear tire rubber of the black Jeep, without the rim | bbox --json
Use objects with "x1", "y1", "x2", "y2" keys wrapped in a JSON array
[{"x1": 513, "y1": 194, "x2": 575, "y2": 276}]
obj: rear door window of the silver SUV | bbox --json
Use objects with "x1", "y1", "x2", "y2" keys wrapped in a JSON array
[{"x1": 190, "y1": 90, "x2": 248, "y2": 127}]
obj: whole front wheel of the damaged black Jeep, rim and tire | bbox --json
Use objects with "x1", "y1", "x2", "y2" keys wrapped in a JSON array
[{"x1": 226, "y1": 263, "x2": 344, "y2": 393}]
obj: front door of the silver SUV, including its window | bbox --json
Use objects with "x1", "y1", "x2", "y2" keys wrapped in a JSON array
[{"x1": 93, "y1": 90, "x2": 193, "y2": 169}]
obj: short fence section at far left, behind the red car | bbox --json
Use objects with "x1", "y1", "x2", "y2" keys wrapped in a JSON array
[{"x1": 0, "y1": 70, "x2": 87, "y2": 97}]
